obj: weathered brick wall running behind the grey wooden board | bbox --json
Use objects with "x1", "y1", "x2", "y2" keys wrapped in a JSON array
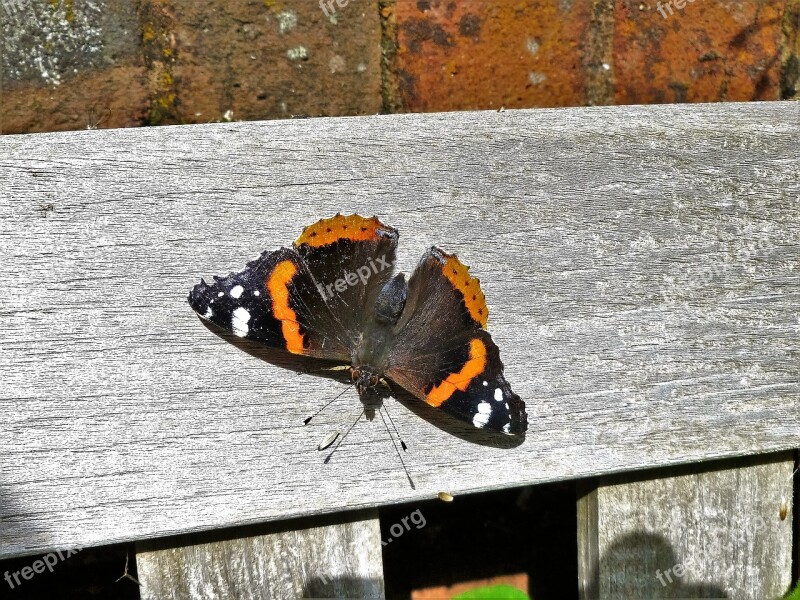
[{"x1": 0, "y1": 0, "x2": 800, "y2": 133}]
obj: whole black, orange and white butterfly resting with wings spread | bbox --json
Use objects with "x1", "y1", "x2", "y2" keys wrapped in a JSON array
[{"x1": 189, "y1": 214, "x2": 527, "y2": 434}]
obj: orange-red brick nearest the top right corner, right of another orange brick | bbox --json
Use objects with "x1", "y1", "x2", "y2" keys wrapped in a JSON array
[{"x1": 614, "y1": 0, "x2": 785, "y2": 104}]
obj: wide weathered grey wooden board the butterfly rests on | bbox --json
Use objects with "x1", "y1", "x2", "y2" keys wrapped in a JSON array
[{"x1": 0, "y1": 103, "x2": 800, "y2": 556}]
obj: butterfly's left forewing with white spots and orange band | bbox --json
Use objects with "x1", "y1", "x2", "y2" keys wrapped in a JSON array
[{"x1": 189, "y1": 248, "x2": 350, "y2": 362}]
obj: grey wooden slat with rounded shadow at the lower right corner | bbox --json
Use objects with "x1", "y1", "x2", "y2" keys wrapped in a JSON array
[{"x1": 578, "y1": 452, "x2": 794, "y2": 600}]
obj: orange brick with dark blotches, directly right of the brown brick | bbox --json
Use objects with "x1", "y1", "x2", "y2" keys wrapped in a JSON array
[{"x1": 394, "y1": 0, "x2": 590, "y2": 111}]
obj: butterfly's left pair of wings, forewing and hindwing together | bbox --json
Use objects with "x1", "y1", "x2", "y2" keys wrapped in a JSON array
[{"x1": 189, "y1": 215, "x2": 398, "y2": 363}]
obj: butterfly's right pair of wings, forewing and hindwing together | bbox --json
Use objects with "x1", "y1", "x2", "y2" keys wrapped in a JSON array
[{"x1": 386, "y1": 247, "x2": 527, "y2": 434}]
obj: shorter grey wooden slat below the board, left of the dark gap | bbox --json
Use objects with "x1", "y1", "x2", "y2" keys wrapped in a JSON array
[{"x1": 136, "y1": 511, "x2": 384, "y2": 600}]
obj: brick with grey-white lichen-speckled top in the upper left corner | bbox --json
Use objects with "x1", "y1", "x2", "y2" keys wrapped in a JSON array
[{"x1": 0, "y1": 0, "x2": 149, "y2": 133}]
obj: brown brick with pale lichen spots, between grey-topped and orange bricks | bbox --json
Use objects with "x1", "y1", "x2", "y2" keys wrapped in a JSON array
[{"x1": 143, "y1": 0, "x2": 381, "y2": 123}]
